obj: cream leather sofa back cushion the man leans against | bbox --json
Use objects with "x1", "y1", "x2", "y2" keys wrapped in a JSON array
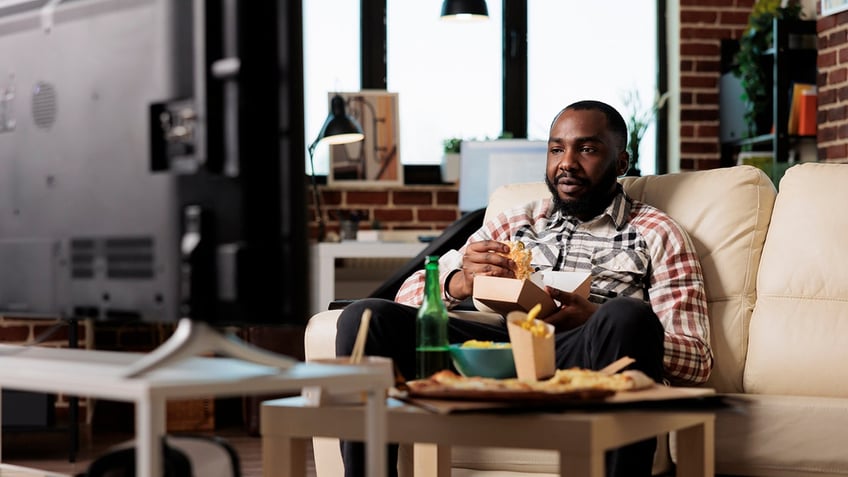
[{"x1": 486, "y1": 166, "x2": 775, "y2": 392}]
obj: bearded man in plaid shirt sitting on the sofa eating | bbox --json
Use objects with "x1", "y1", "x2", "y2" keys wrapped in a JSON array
[{"x1": 336, "y1": 101, "x2": 712, "y2": 477}]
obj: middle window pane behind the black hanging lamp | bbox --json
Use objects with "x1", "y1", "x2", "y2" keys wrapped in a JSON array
[{"x1": 386, "y1": 0, "x2": 503, "y2": 164}]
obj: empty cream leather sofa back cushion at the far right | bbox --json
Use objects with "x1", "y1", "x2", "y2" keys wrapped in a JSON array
[{"x1": 744, "y1": 163, "x2": 848, "y2": 397}]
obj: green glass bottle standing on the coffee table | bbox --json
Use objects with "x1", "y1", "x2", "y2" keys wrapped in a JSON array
[{"x1": 415, "y1": 255, "x2": 450, "y2": 379}]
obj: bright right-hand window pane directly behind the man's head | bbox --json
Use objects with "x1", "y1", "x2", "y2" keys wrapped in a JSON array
[{"x1": 527, "y1": 0, "x2": 657, "y2": 174}]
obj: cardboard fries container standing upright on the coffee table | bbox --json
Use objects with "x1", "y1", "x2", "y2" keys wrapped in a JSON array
[{"x1": 506, "y1": 311, "x2": 556, "y2": 382}]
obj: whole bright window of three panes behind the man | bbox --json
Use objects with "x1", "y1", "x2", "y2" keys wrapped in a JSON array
[{"x1": 303, "y1": 0, "x2": 658, "y2": 174}]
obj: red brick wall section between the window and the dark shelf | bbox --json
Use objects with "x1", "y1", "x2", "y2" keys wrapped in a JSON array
[{"x1": 680, "y1": 0, "x2": 756, "y2": 170}]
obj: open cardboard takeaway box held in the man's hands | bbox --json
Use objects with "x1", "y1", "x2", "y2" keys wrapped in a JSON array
[{"x1": 474, "y1": 271, "x2": 592, "y2": 318}]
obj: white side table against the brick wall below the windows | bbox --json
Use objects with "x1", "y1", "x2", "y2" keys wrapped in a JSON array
[{"x1": 309, "y1": 241, "x2": 427, "y2": 315}]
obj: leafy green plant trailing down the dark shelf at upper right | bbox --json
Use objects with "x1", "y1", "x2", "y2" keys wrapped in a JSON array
[{"x1": 735, "y1": 0, "x2": 801, "y2": 136}]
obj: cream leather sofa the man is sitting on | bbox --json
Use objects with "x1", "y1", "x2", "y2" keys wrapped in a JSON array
[{"x1": 305, "y1": 163, "x2": 848, "y2": 477}]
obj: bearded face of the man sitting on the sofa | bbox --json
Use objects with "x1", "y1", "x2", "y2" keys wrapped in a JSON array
[{"x1": 545, "y1": 110, "x2": 627, "y2": 220}]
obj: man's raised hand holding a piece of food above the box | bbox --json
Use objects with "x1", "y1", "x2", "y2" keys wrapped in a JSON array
[{"x1": 447, "y1": 240, "x2": 515, "y2": 300}]
